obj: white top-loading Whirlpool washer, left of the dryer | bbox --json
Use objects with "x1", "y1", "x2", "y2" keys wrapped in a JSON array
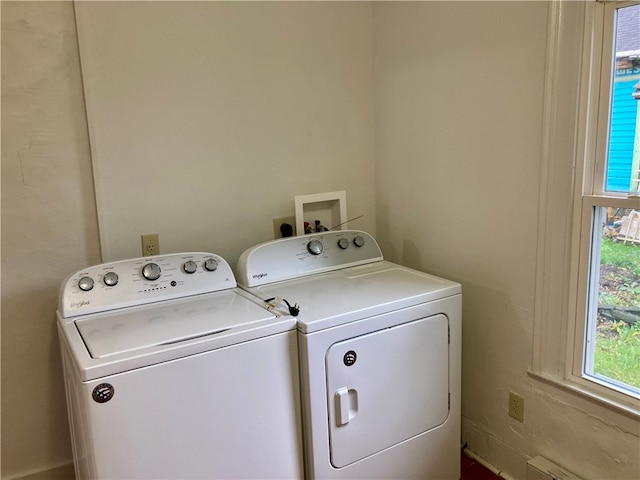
[{"x1": 57, "y1": 253, "x2": 303, "y2": 480}]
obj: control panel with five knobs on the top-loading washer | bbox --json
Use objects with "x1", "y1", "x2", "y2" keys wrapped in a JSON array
[{"x1": 58, "y1": 252, "x2": 236, "y2": 318}]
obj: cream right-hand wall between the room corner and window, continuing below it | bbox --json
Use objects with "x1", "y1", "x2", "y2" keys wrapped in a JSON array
[{"x1": 374, "y1": 2, "x2": 640, "y2": 479}]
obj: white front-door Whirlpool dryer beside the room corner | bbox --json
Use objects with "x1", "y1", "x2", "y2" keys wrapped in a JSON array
[{"x1": 236, "y1": 231, "x2": 461, "y2": 480}]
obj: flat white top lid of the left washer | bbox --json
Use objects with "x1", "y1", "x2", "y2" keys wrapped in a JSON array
[{"x1": 75, "y1": 290, "x2": 275, "y2": 358}]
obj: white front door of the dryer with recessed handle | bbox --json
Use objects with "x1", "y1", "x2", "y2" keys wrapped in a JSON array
[{"x1": 326, "y1": 315, "x2": 449, "y2": 468}]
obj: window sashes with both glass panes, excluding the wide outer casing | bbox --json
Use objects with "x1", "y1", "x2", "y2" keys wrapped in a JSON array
[{"x1": 572, "y1": 2, "x2": 640, "y2": 398}]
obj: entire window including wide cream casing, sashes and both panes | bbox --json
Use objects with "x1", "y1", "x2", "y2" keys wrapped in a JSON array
[{"x1": 530, "y1": 0, "x2": 640, "y2": 418}]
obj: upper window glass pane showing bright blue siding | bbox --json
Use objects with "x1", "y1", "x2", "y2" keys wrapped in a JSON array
[{"x1": 605, "y1": 5, "x2": 640, "y2": 193}]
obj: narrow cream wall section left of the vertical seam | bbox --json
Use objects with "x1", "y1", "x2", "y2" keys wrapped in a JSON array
[{"x1": 2, "y1": 2, "x2": 100, "y2": 478}]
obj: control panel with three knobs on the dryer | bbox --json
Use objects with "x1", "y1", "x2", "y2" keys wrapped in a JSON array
[{"x1": 236, "y1": 230, "x2": 383, "y2": 287}]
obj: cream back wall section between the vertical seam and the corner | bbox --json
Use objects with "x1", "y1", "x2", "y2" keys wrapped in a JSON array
[{"x1": 76, "y1": 2, "x2": 375, "y2": 263}]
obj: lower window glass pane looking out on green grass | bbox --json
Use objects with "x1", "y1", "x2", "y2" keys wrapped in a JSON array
[{"x1": 584, "y1": 207, "x2": 640, "y2": 396}]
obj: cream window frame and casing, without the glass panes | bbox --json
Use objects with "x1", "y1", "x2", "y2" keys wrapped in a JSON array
[{"x1": 529, "y1": 0, "x2": 640, "y2": 419}]
